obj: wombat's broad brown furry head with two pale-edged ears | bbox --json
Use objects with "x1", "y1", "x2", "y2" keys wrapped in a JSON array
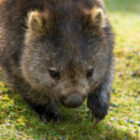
[{"x1": 21, "y1": 7, "x2": 112, "y2": 107}]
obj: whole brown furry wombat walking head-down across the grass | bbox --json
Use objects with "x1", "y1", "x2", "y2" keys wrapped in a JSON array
[{"x1": 0, "y1": 0, "x2": 114, "y2": 121}]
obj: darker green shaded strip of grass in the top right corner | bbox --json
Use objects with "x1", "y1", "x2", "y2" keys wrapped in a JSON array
[{"x1": 104, "y1": 0, "x2": 140, "y2": 14}]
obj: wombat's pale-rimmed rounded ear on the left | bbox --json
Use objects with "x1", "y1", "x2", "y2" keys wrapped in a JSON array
[{"x1": 27, "y1": 11, "x2": 44, "y2": 32}]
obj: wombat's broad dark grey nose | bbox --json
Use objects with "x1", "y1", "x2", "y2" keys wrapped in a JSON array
[{"x1": 63, "y1": 94, "x2": 83, "y2": 108}]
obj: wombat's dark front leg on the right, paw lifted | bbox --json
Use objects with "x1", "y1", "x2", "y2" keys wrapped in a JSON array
[{"x1": 87, "y1": 74, "x2": 112, "y2": 122}]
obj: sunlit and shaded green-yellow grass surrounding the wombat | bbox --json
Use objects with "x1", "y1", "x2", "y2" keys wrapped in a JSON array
[{"x1": 0, "y1": 0, "x2": 140, "y2": 140}]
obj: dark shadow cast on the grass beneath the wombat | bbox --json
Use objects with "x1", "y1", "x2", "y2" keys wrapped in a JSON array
[{"x1": 0, "y1": 94, "x2": 137, "y2": 140}]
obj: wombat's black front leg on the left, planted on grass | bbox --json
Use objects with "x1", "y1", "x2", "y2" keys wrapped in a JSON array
[{"x1": 26, "y1": 99, "x2": 60, "y2": 123}]
